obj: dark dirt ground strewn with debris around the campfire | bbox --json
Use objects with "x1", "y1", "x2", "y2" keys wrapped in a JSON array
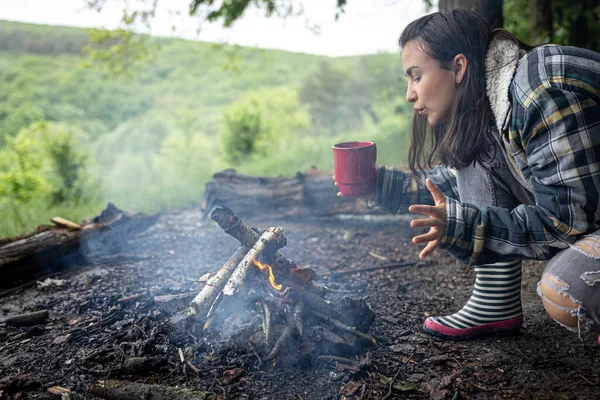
[{"x1": 0, "y1": 209, "x2": 600, "y2": 399}]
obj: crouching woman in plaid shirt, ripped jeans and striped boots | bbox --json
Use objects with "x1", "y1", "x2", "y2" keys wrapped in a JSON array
[{"x1": 336, "y1": 10, "x2": 600, "y2": 341}]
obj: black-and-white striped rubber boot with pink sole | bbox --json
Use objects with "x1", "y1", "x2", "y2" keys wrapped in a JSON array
[{"x1": 424, "y1": 261, "x2": 523, "y2": 340}]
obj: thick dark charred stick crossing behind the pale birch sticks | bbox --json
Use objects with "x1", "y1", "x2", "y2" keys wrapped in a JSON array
[{"x1": 210, "y1": 207, "x2": 328, "y2": 297}]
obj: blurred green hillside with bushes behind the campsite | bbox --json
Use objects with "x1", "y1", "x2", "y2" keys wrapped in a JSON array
[{"x1": 0, "y1": 21, "x2": 410, "y2": 235}]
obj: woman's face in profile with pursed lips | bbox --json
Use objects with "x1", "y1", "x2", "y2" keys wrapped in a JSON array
[{"x1": 402, "y1": 40, "x2": 464, "y2": 126}]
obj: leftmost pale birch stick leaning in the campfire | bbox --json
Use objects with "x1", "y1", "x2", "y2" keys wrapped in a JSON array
[{"x1": 188, "y1": 246, "x2": 249, "y2": 319}]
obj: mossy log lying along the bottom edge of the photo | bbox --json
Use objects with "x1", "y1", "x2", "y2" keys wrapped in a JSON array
[{"x1": 87, "y1": 380, "x2": 219, "y2": 400}]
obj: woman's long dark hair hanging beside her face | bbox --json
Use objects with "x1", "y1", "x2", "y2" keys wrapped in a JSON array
[{"x1": 399, "y1": 9, "x2": 531, "y2": 174}]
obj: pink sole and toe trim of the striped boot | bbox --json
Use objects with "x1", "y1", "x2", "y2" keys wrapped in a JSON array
[{"x1": 423, "y1": 317, "x2": 523, "y2": 340}]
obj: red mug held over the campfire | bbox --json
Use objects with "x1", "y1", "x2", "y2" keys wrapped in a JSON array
[{"x1": 333, "y1": 140, "x2": 377, "y2": 196}]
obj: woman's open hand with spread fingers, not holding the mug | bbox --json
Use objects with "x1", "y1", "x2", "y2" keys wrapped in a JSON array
[{"x1": 408, "y1": 178, "x2": 446, "y2": 260}]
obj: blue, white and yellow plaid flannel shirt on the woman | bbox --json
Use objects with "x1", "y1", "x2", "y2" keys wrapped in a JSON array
[{"x1": 376, "y1": 46, "x2": 600, "y2": 265}]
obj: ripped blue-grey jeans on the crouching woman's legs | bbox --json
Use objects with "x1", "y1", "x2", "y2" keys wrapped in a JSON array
[{"x1": 456, "y1": 143, "x2": 600, "y2": 332}]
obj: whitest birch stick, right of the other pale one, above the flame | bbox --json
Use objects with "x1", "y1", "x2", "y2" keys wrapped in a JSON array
[{"x1": 223, "y1": 227, "x2": 286, "y2": 296}]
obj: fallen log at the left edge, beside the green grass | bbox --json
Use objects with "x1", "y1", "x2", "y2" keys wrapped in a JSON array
[{"x1": 0, "y1": 203, "x2": 158, "y2": 289}]
